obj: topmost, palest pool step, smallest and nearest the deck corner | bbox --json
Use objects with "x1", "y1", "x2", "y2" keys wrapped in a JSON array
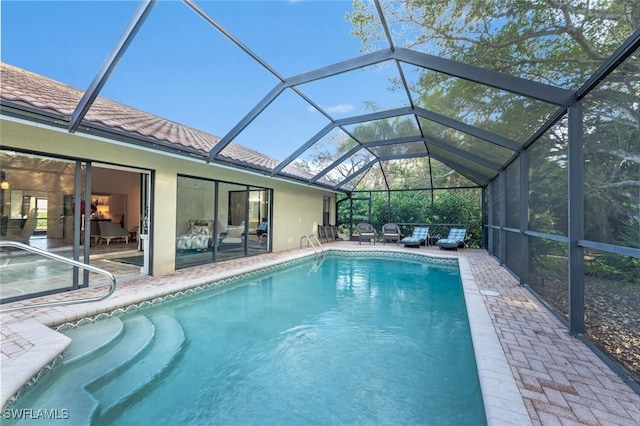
[{"x1": 62, "y1": 317, "x2": 124, "y2": 364}]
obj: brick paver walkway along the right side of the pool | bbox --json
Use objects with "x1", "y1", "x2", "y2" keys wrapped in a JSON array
[{"x1": 461, "y1": 250, "x2": 640, "y2": 425}]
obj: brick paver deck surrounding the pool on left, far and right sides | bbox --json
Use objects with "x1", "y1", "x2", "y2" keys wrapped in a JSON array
[{"x1": 0, "y1": 242, "x2": 640, "y2": 426}]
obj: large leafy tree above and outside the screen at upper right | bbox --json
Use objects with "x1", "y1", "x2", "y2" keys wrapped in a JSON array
[{"x1": 347, "y1": 0, "x2": 640, "y2": 247}]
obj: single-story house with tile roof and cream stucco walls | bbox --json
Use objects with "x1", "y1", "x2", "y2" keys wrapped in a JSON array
[{"x1": 0, "y1": 63, "x2": 335, "y2": 282}]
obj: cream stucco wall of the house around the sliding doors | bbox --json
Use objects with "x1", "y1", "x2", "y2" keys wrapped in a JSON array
[{"x1": 0, "y1": 117, "x2": 335, "y2": 275}]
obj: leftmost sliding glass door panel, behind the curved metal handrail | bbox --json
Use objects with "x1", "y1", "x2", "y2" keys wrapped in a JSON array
[{"x1": 0, "y1": 150, "x2": 80, "y2": 302}]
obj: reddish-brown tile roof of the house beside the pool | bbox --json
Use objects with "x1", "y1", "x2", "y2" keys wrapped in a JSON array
[{"x1": 0, "y1": 62, "x2": 296, "y2": 178}]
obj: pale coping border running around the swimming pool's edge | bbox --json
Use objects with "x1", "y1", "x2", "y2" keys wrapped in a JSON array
[{"x1": 0, "y1": 246, "x2": 532, "y2": 425}]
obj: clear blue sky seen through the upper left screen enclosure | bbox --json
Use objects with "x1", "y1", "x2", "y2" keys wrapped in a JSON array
[{"x1": 0, "y1": 0, "x2": 402, "y2": 160}]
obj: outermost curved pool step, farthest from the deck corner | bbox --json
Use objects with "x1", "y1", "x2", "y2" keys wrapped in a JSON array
[{"x1": 87, "y1": 315, "x2": 185, "y2": 417}]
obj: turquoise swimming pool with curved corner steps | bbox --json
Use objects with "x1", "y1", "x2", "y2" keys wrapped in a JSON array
[{"x1": 6, "y1": 256, "x2": 485, "y2": 424}]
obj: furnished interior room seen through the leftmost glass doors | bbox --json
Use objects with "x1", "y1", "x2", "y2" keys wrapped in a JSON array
[{"x1": 0, "y1": 151, "x2": 141, "y2": 254}]
